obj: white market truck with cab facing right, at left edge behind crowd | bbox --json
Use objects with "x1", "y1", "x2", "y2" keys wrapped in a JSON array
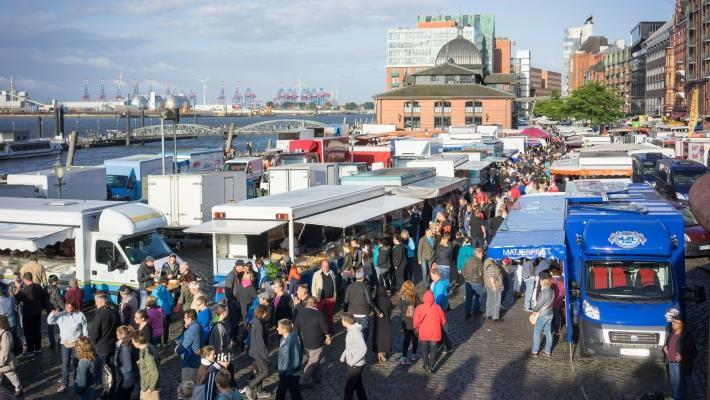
[{"x1": 0, "y1": 197, "x2": 177, "y2": 300}]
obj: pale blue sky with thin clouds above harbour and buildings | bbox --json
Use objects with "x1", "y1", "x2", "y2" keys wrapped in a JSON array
[{"x1": 0, "y1": 0, "x2": 675, "y2": 103}]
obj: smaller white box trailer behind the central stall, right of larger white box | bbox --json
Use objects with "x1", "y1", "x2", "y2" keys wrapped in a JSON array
[{"x1": 267, "y1": 163, "x2": 339, "y2": 195}]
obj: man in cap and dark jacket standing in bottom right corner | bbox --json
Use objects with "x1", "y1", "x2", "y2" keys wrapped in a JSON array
[{"x1": 663, "y1": 313, "x2": 698, "y2": 399}]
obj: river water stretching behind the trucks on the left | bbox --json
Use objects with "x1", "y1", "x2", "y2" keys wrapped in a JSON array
[{"x1": 0, "y1": 114, "x2": 373, "y2": 175}]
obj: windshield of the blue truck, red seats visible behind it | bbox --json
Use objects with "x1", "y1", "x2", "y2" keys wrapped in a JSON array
[{"x1": 586, "y1": 261, "x2": 673, "y2": 300}]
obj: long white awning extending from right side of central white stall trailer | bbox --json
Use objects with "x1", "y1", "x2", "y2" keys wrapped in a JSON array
[{"x1": 296, "y1": 195, "x2": 421, "y2": 228}]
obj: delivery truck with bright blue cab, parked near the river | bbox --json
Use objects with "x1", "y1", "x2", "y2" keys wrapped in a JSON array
[{"x1": 104, "y1": 154, "x2": 173, "y2": 200}]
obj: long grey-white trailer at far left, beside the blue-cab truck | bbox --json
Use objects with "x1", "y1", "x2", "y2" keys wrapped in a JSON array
[{"x1": 7, "y1": 166, "x2": 106, "y2": 200}]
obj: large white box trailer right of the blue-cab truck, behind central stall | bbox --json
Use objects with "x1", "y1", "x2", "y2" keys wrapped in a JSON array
[{"x1": 148, "y1": 172, "x2": 247, "y2": 228}]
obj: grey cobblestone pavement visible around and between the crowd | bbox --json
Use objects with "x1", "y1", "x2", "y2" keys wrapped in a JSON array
[{"x1": 4, "y1": 244, "x2": 710, "y2": 400}]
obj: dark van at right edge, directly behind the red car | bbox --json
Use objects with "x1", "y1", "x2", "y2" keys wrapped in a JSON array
[{"x1": 654, "y1": 158, "x2": 708, "y2": 200}]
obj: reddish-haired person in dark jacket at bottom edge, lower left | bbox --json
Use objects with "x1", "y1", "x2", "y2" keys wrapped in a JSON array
[{"x1": 113, "y1": 325, "x2": 140, "y2": 400}]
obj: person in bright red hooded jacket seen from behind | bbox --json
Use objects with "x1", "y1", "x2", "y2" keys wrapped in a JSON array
[{"x1": 414, "y1": 290, "x2": 446, "y2": 374}]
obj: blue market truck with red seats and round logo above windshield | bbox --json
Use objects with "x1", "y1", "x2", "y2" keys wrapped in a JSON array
[{"x1": 564, "y1": 180, "x2": 704, "y2": 359}]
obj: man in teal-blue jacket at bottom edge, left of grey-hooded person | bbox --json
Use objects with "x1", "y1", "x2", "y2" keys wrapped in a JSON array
[{"x1": 276, "y1": 318, "x2": 303, "y2": 400}]
